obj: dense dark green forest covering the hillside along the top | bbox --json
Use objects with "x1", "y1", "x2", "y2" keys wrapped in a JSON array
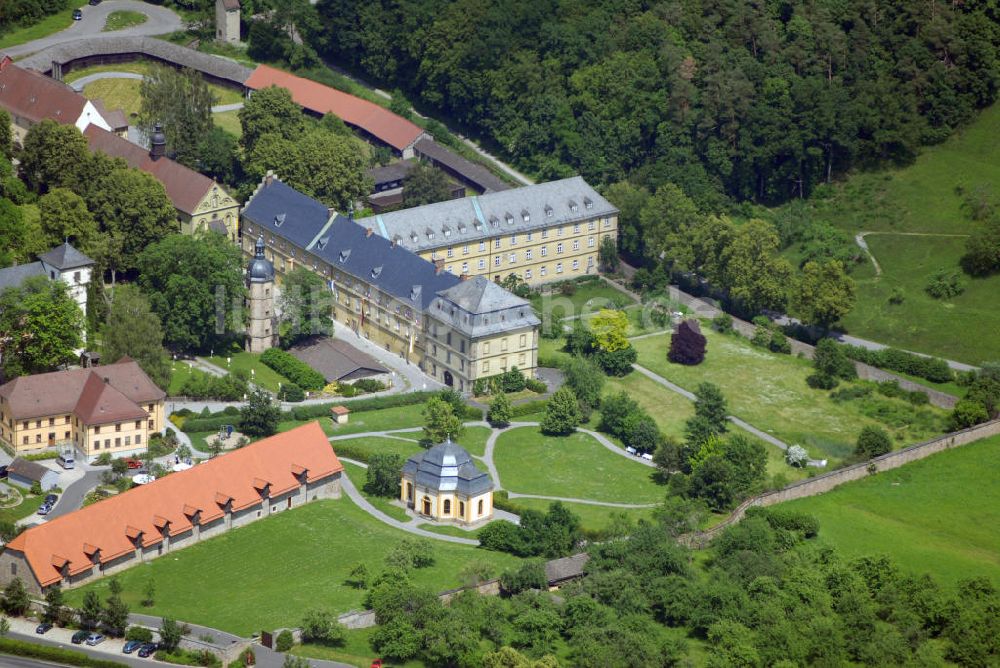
[{"x1": 309, "y1": 0, "x2": 1000, "y2": 210}]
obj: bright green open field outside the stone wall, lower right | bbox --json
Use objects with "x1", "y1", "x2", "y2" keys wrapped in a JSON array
[{"x1": 784, "y1": 437, "x2": 1000, "y2": 585}]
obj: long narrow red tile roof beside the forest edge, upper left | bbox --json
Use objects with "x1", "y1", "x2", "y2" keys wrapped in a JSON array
[{"x1": 246, "y1": 65, "x2": 424, "y2": 151}]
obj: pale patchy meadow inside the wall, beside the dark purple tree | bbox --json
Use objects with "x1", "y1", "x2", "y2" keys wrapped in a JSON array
[{"x1": 635, "y1": 327, "x2": 945, "y2": 460}]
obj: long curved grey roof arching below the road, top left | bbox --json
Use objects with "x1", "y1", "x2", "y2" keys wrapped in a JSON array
[{"x1": 18, "y1": 35, "x2": 253, "y2": 86}]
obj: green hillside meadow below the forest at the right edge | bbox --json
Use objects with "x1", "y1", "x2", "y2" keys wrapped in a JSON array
[{"x1": 776, "y1": 105, "x2": 1000, "y2": 364}]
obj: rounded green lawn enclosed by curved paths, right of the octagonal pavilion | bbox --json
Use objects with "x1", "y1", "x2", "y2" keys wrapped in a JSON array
[{"x1": 493, "y1": 427, "x2": 665, "y2": 503}]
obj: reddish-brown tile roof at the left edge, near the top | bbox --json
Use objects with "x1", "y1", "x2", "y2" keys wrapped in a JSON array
[{"x1": 0, "y1": 56, "x2": 87, "y2": 125}]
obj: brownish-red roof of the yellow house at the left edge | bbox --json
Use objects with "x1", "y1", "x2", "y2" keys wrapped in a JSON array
[{"x1": 0, "y1": 357, "x2": 166, "y2": 424}]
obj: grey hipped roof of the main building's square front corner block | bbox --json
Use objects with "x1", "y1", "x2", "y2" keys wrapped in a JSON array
[{"x1": 431, "y1": 276, "x2": 541, "y2": 337}]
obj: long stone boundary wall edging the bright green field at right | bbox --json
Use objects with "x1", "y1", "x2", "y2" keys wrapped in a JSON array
[{"x1": 680, "y1": 420, "x2": 1000, "y2": 547}]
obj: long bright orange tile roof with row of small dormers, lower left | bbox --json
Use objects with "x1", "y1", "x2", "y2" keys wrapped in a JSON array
[{"x1": 7, "y1": 422, "x2": 344, "y2": 587}]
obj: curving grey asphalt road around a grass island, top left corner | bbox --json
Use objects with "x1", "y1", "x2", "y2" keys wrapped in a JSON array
[{"x1": 3, "y1": 0, "x2": 184, "y2": 58}]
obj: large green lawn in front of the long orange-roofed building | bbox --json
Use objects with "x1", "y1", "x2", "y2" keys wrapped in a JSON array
[{"x1": 66, "y1": 497, "x2": 518, "y2": 635}]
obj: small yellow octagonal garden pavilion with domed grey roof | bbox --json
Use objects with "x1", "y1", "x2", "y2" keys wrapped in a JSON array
[{"x1": 400, "y1": 439, "x2": 493, "y2": 524}]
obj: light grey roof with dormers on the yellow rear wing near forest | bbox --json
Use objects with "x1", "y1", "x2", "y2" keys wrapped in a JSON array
[{"x1": 358, "y1": 176, "x2": 618, "y2": 252}]
